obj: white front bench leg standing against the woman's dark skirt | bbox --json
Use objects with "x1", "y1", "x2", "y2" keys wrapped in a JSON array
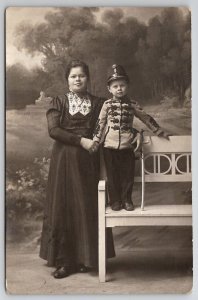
[{"x1": 98, "y1": 190, "x2": 106, "y2": 282}]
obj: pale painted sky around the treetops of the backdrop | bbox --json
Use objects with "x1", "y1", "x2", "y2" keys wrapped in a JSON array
[{"x1": 6, "y1": 7, "x2": 189, "y2": 68}]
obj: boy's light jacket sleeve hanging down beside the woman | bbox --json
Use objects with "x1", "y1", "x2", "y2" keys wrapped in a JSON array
[{"x1": 93, "y1": 103, "x2": 107, "y2": 143}]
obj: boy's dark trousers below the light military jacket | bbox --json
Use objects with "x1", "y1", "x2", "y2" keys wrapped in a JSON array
[{"x1": 103, "y1": 148, "x2": 135, "y2": 205}]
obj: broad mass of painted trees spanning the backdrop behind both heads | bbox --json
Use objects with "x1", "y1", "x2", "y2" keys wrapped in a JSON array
[{"x1": 11, "y1": 8, "x2": 191, "y2": 104}]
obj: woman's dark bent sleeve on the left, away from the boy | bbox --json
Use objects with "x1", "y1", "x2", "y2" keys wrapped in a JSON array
[{"x1": 46, "y1": 97, "x2": 81, "y2": 146}]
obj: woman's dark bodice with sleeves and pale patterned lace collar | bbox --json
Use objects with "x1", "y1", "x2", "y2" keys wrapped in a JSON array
[{"x1": 47, "y1": 92, "x2": 103, "y2": 145}]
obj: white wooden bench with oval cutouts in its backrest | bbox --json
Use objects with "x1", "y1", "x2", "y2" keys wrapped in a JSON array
[{"x1": 98, "y1": 136, "x2": 192, "y2": 282}]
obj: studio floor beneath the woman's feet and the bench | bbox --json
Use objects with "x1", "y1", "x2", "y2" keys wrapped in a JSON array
[{"x1": 6, "y1": 247, "x2": 192, "y2": 295}]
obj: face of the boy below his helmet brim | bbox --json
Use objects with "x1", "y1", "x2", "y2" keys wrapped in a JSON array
[{"x1": 108, "y1": 79, "x2": 128, "y2": 98}]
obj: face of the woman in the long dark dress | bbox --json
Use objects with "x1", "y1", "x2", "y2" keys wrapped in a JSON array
[{"x1": 68, "y1": 67, "x2": 88, "y2": 93}]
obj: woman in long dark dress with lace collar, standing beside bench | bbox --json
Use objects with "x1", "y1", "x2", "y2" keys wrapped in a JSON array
[{"x1": 40, "y1": 60, "x2": 115, "y2": 278}]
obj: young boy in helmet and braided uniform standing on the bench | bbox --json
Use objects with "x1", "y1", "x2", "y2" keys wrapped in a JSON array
[{"x1": 93, "y1": 65, "x2": 168, "y2": 211}]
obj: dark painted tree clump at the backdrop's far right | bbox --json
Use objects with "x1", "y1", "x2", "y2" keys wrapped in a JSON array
[{"x1": 136, "y1": 8, "x2": 191, "y2": 105}]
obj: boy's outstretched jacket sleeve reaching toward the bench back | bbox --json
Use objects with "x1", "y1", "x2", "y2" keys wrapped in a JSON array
[{"x1": 132, "y1": 101, "x2": 163, "y2": 135}]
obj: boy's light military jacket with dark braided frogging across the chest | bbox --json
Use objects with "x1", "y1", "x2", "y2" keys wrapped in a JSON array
[{"x1": 93, "y1": 96, "x2": 162, "y2": 149}]
